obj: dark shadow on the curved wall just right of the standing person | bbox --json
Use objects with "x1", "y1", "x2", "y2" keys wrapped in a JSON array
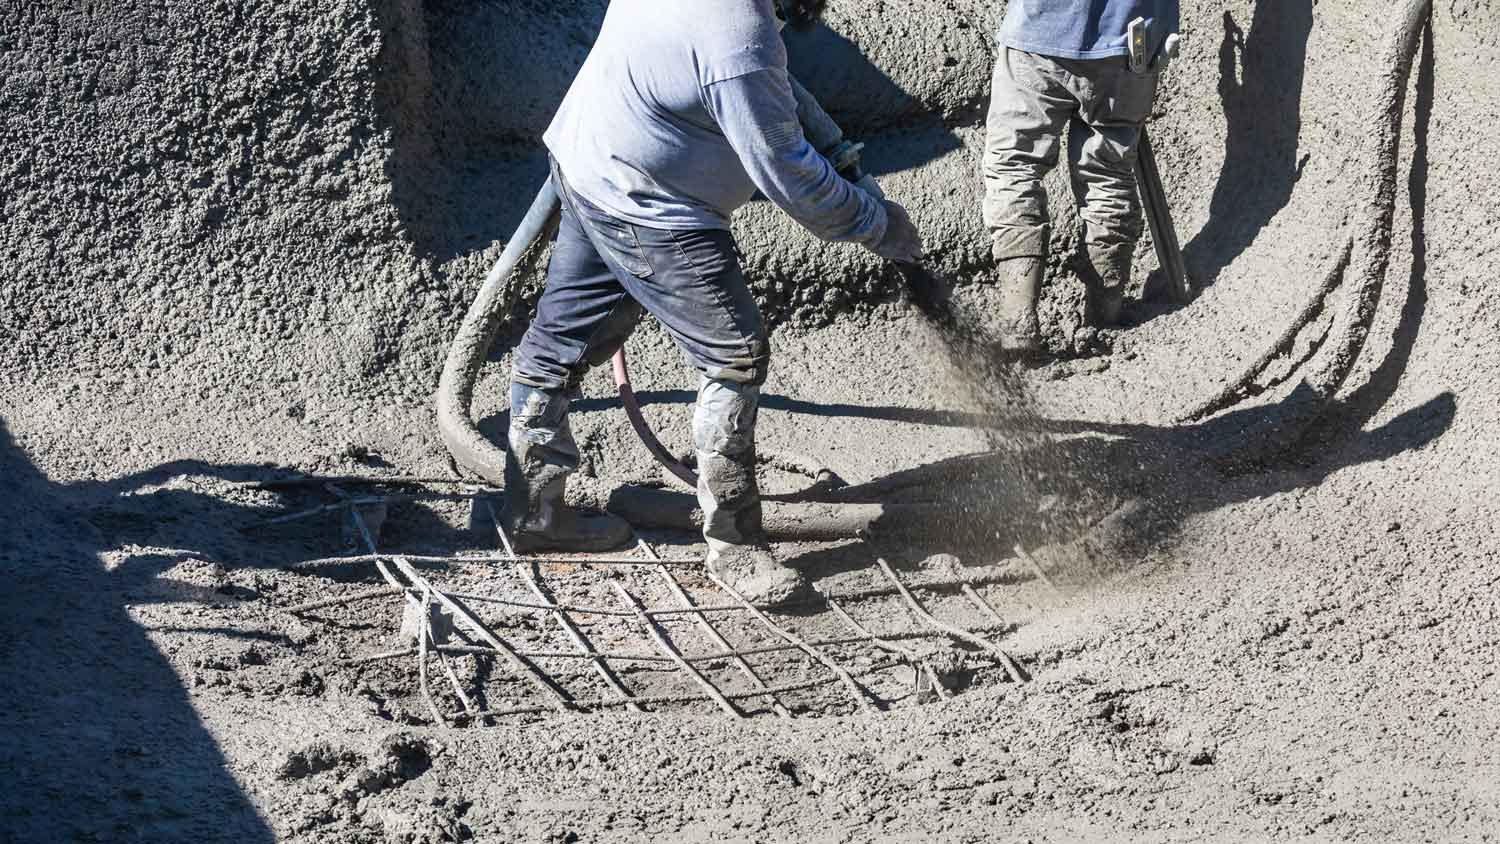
[{"x1": 1137, "y1": 0, "x2": 1313, "y2": 321}]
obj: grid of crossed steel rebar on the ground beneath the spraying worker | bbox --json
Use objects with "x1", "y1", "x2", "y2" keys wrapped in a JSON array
[{"x1": 276, "y1": 483, "x2": 1028, "y2": 726}]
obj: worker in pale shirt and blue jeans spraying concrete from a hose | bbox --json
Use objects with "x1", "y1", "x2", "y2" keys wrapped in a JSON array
[{"x1": 506, "y1": 0, "x2": 921, "y2": 600}]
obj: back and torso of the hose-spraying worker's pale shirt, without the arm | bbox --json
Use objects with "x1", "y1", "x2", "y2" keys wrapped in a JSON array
[{"x1": 546, "y1": 0, "x2": 786, "y2": 229}]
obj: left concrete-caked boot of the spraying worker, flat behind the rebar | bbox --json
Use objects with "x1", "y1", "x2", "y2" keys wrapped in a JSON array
[{"x1": 506, "y1": 382, "x2": 633, "y2": 552}]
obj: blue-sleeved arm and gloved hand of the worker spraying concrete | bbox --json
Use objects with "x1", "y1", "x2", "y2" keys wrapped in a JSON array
[{"x1": 704, "y1": 70, "x2": 921, "y2": 261}]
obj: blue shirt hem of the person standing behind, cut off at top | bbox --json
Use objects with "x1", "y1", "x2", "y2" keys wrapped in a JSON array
[{"x1": 1001, "y1": 0, "x2": 1178, "y2": 58}]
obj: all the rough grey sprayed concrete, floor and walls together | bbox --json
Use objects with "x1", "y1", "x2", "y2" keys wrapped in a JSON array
[{"x1": 0, "y1": 0, "x2": 1500, "y2": 841}]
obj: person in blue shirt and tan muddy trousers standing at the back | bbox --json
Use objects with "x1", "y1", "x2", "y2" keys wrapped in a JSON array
[{"x1": 980, "y1": 0, "x2": 1178, "y2": 354}]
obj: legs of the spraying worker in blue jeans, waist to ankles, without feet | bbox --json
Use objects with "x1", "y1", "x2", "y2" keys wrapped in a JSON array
[{"x1": 507, "y1": 165, "x2": 770, "y2": 544}]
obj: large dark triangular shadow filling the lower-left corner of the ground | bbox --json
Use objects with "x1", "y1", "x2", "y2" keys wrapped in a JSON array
[{"x1": 0, "y1": 418, "x2": 275, "y2": 843}]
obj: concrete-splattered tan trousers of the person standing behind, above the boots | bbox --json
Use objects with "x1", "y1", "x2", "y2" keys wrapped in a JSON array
[{"x1": 983, "y1": 46, "x2": 1157, "y2": 261}]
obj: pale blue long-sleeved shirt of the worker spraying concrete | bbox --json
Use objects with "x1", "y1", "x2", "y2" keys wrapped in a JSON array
[{"x1": 543, "y1": 0, "x2": 888, "y2": 249}]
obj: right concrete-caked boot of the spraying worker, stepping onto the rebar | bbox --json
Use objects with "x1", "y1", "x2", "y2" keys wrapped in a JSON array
[{"x1": 693, "y1": 378, "x2": 806, "y2": 603}]
